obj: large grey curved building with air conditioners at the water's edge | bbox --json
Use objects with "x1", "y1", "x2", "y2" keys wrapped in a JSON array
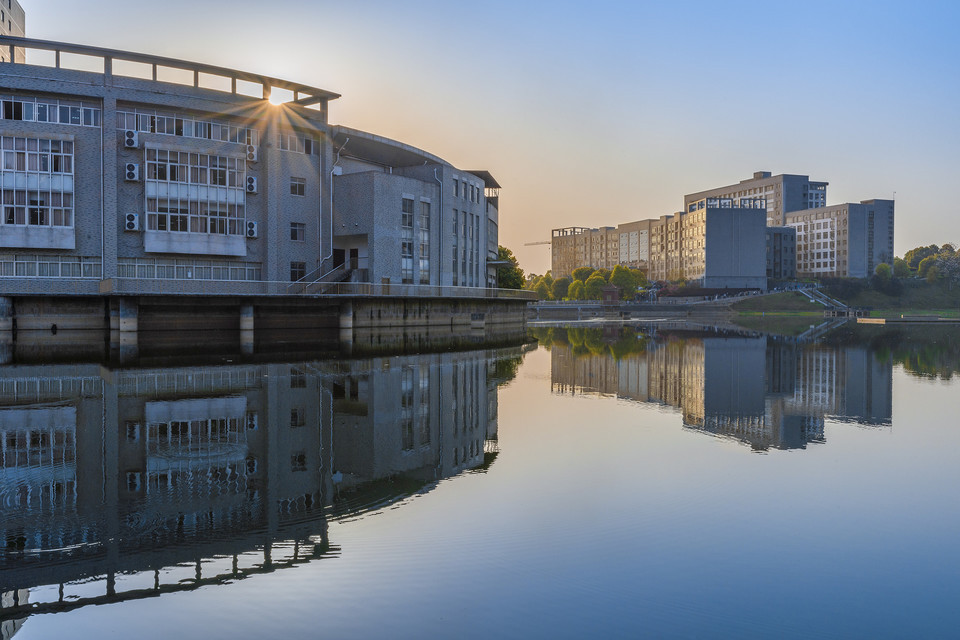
[{"x1": 0, "y1": 37, "x2": 499, "y2": 295}]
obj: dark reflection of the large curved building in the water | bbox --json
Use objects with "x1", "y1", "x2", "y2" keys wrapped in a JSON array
[{"x1": 0, "y1": 348, "x2": 522, "y2": 640}]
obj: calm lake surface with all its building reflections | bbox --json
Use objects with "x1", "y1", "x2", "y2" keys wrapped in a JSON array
[{"x1": 0, "y1": 328, "x2": 960, "y2": 640}]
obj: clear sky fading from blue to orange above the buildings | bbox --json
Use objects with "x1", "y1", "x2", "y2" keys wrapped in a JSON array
[{"x1": 22, "y1": 0, "x2": 960, "y2": 273}]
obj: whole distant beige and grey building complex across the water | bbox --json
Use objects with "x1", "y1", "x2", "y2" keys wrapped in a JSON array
[{"x1": 551, "y1": 171, "x2": 894, "y2": 288}]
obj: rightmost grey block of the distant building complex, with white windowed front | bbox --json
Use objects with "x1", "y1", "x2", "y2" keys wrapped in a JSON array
[{"x1": 786, "y1": 200, "x2": 894, "y2": 278}]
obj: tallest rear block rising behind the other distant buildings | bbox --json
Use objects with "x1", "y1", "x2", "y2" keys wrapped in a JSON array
[{"x1": 683, "y1": 171, "x2": 829, "y2": 226}]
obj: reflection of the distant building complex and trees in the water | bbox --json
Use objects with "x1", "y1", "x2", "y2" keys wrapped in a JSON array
[{"x1": 548, "y1": 329, "x2": 892, "y2": 451}]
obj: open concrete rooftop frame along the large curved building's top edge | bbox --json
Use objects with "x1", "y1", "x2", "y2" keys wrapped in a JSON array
[{"x1": 0, "y1": 36, "x2": 340, "y2": 107}]
